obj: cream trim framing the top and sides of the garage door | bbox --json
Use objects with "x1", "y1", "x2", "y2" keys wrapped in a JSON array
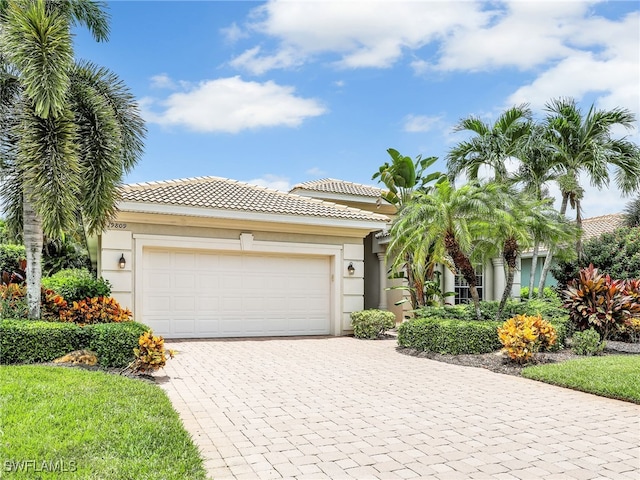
[{"x1": 133, "y1": 234, "x2": 343, "y2": 335}]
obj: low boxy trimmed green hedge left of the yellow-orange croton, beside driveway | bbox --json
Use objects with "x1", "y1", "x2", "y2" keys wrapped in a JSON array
[{"x1": 398, "y1": 318, "x2": 500, "y2": 355}]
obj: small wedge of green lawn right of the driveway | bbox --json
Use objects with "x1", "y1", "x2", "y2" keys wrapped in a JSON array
[{"x1": 522, "y1": 355, "x2": 640, "y2": 404}]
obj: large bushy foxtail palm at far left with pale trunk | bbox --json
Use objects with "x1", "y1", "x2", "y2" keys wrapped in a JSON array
[{"x1": 0, "y1": 0, "x2": 145, "y2": 318}]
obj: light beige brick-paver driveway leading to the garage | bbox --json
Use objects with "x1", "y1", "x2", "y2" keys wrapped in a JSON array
[{"x1": 162, "y1": 337, "x2": 640, "y2": 479}]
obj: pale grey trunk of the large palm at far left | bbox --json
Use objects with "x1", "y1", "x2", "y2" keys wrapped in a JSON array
[{"x1": 22, "y1": 193, "x2": 44, "y2": 319}]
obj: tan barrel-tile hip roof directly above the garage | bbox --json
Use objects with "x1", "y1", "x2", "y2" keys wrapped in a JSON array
[{"x1": 120, "y1": 177, "x2": 388, "y2": 222}]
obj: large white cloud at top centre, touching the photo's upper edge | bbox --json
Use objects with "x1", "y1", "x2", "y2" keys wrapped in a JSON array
[{"x1": 232, "y1": 0, "x2": 486, "y2": 73}]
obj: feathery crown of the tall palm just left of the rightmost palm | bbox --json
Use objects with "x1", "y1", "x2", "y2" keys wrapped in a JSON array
[{"x1": 447, "y1": 105, "x2": 531, "y2": 181}]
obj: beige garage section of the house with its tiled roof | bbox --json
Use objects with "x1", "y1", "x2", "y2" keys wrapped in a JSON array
[{"x1": 93, "y1": 177, "x2": 389, "y2": 338}]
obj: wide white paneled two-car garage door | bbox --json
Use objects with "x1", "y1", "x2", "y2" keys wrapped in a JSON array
[{"x1": 142, "y1": 249, "x2": 331, "y2": 338}]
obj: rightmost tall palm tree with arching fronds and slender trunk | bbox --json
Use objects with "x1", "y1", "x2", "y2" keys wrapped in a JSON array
[{"x1": 538, "y1": 98, "x2": 640, "y2": 296}]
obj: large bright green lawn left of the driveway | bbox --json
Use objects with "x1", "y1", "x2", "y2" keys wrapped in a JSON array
[{"x1": 0, "y1": 365, "x2": 206, "y2": 480}]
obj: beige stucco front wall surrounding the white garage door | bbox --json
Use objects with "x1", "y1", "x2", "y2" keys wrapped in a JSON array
[{"x1": 98, "y1": 212, "x2": 369, "y2": 335}]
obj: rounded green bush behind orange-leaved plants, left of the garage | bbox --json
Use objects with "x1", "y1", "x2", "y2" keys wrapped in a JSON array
[{"x1": 42, "y1": 268, "x2": 111, "y2": 302}]
